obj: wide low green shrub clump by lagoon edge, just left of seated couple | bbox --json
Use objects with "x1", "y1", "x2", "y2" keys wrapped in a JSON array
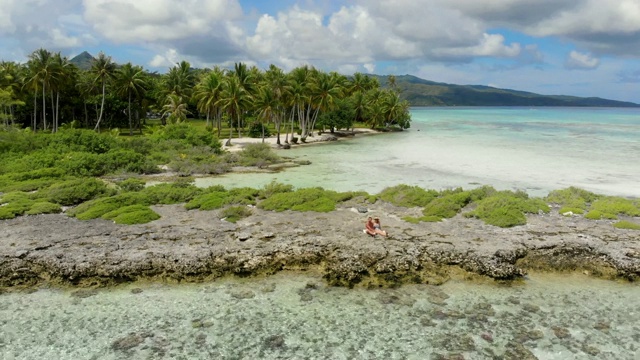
[{"x1": 258, "y1": 187, "x2": 336, "y2": 212}]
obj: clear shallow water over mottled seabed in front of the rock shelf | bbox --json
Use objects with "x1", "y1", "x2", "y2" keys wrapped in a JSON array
[{"x1": 0, "y1": 274, "x2": 640, "y2": 360}]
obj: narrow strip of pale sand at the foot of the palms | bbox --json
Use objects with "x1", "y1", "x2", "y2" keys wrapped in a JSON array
[{"x1": 221, "y1": 128, "x2": 381, "y2": 152}]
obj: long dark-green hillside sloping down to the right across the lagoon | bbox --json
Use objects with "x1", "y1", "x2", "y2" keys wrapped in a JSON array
[{"x1": 373, "y1": 75, "x2": 640, "y2": 107}]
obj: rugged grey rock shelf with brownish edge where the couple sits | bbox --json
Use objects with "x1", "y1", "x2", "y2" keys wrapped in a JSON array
[{"x1": 0, "y1": 202, "x2": 640, "y2": 290}]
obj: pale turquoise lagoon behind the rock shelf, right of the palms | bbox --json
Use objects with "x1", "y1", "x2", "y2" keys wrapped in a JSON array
[{"x1": 197, "y1": 107, "x2": 640, "y2": 197}]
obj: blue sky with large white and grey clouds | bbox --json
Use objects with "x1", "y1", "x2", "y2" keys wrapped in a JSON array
[{"x1": 0, "y1": 0, "x2": 640, "y2": 103}]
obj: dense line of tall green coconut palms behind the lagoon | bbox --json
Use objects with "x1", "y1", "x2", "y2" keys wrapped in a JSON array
[{"x1": 0, "y1": 48, "x2": 410, "y2": 143}]
